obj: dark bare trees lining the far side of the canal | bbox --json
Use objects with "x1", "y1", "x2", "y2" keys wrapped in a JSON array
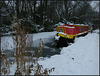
[{"x1": 0, "y1": 0, "x2": 99, "y2": 32}]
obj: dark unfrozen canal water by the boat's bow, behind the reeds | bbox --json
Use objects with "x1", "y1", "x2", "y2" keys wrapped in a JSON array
[{"x1": 4, "y1": 37, "x2": 61, "y2": 62}]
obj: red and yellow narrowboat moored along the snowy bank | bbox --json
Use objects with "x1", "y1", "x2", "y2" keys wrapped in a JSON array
[{"x1": 55, "y1": 24, "x2": 90, "y2": 45}]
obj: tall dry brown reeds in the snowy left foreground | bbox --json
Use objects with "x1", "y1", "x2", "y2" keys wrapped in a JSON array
[{"x1": 1, "y1": 17, "x2": 55, "y2": 76}]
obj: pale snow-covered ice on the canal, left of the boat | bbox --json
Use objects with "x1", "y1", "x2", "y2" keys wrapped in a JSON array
[{"x1": 1, "y1": 31, "x2": 57, "y2": 50}]
